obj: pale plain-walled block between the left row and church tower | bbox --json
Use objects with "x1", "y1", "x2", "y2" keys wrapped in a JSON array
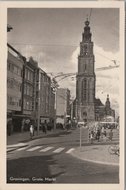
[{"x1": 56, "y1": 88, "x2": 70, "y2": 124}]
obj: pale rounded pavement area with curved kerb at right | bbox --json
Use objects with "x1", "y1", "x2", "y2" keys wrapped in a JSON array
[{"x1": 71, "y1": 141, "x2": 119, "y2": 166}]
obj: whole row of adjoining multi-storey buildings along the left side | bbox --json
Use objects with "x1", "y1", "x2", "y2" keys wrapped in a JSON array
[{"x1": 7, "y1": 44, "x2": 55, "y2": 133}]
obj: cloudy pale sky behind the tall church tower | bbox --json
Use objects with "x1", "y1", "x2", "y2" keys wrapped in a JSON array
[{"x1": 7, "y1": 8, "x2": 120, "y2": 116}]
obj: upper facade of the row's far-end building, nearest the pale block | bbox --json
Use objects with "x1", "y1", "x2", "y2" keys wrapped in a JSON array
[{"x1": 36, "y1": 68, "x2": 55, "y2": 123}]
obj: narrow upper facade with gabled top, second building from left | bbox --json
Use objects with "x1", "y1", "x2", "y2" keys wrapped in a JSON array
[{"x1": 22, "y1": 57, "x2": 38, "y2": 118}]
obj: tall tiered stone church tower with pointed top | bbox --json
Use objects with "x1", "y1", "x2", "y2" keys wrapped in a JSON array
[{"x1": 76, "y1": 20, "x2": 95, "y2": 121}]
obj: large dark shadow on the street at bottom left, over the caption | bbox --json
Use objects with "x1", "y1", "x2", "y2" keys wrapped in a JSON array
[{"x1": 7, "y1": 155, "x2": 63, "y2": 183}]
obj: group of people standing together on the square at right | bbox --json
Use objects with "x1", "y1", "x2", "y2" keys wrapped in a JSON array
[{"x1": 89, "y1": 127, "x2": 113, "y2": 144}]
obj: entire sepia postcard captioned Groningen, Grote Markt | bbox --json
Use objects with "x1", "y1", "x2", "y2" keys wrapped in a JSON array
[{"x1": 0, "y1": 2, "x2": 124, "y2": 190}]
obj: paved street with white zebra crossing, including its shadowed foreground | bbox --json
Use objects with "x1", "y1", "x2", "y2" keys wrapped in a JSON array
[{"x1": 7, "y1": 128, "x2": 119, "y2": 183}]
